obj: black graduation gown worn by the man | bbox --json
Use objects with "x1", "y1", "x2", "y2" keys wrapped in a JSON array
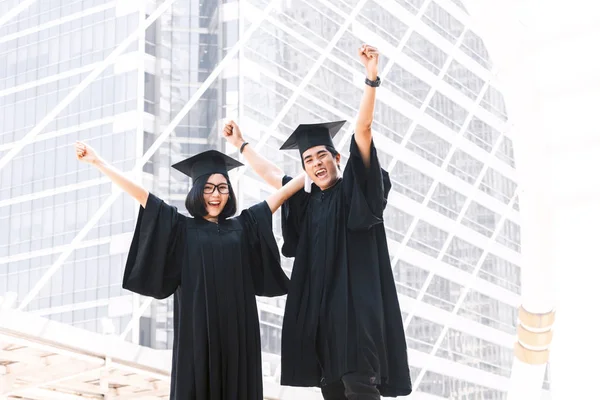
[{"x1": 281, "y1": 137, "x2": 412, "y2": 397}]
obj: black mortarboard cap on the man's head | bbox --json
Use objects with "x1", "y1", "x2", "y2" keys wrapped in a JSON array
[{"x1": 279, "y1": 121, "x2": 346, "y2": 156}]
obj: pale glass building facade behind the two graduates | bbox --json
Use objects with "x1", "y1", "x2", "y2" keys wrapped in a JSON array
[{"x1": 0, "y1": 0, "x2": 548, "y2": 399}]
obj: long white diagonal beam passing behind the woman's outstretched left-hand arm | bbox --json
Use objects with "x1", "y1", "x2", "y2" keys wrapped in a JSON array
[{"x1": 18, "y1": 0, "x2": 279, "y2": 312}]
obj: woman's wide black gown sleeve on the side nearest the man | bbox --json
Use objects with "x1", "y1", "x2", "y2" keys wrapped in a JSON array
[{"x1": 240, "y1": 201, "x2": 289, "y2": 297}]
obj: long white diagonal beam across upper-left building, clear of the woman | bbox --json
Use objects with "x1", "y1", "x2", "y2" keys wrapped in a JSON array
[{"x1": 0, "y1": 0, "x2": 175, "y2": 170}]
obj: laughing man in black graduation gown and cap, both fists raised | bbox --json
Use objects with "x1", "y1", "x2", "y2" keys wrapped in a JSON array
[{"x1": 225, "y1": 46, "x2": 412, "y2": 400}]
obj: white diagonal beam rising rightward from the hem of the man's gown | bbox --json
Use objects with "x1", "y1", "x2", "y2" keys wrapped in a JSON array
[{"x1": 413, "y1": 187, "x2": 520, "y2": 392}]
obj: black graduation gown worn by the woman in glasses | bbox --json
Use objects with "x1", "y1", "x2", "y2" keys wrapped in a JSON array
[{"x1": 123, "y1": 194, "x2": 288, "y2": 400}]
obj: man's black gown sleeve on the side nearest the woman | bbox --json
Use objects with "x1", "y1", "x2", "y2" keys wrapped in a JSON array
[{"x1": 281, "y1": 175, "x2": 310, "y2": 257}]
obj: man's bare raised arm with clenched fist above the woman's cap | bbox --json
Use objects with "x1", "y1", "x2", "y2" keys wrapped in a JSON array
[{"x1": 223, "y1": 121, "x2": 284, "y2": 189}]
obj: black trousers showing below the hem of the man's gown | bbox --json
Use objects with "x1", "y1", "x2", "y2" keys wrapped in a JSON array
[{"x1": 321, "y1": 373, "x2": 381, "y2": 400}]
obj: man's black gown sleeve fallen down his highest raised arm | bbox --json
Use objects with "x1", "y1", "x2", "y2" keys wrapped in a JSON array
[{"x1": 344, "y1": 135, "x2": 392, "y2": 231}]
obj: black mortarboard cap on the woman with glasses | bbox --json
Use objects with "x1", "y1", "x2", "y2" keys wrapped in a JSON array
[{"x1": 172, "y1": 150, "x2": 244, "y2": 183}]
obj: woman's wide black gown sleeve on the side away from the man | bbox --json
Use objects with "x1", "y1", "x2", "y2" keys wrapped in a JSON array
[{"x1": 123, "y1": 193, "x2": 185, "y2": 299}]
